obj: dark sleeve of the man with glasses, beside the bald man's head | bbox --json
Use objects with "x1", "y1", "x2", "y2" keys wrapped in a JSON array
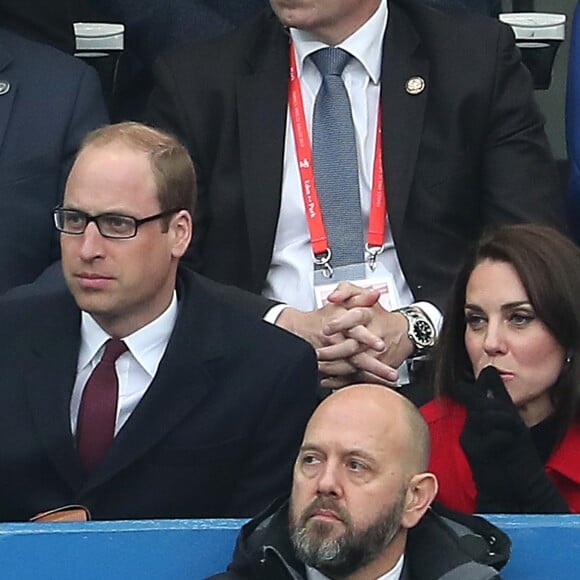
[{"x1": 228, "y1": 338, "x2": 320, "y2": 517}]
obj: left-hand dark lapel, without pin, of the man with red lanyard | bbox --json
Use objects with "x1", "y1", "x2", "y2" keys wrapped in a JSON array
[{"x1": 237, "y1": 15, "x2": 289, "y2": 289}]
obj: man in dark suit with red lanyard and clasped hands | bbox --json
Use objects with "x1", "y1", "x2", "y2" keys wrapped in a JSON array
[{"x1": 150, "y1": 0, "x2": 563, "y2": 387}]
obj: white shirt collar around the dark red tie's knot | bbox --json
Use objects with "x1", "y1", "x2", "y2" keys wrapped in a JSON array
[{"x1": 77, "y1": 290, "x2": 177, "y2": 378}]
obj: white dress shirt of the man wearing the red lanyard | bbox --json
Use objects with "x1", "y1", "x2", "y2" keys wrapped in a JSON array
[{"x1": 263, "y1": 0, "x2": 441, "y2": 326}]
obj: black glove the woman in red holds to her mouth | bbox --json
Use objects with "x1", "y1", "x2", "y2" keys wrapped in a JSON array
[{"x1": 458, "y1": 366, "x2": 569, "y2": 513}]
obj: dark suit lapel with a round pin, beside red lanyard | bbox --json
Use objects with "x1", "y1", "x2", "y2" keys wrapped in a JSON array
[{"x1": 381, "y1": 2, "x2": 429, "y2": 244}]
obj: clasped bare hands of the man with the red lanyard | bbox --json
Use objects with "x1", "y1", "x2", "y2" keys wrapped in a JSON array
[{"x1": 276, "y1": 282, "x2": 413, "y2": 389}]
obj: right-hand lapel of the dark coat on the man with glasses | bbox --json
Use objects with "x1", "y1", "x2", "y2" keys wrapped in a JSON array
[{"x1": 82, "y1": 272, "x2": 223, "y2": 494}]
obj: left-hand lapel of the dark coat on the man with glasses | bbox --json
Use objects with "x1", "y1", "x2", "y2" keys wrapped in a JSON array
[{"x1": 25, "y1": 296, "x2": 84, "y2": 492}]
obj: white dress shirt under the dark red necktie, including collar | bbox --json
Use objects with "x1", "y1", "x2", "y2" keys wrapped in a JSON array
[{"x1": 70, "y1": 291, "x2": 177, "y2": 435}]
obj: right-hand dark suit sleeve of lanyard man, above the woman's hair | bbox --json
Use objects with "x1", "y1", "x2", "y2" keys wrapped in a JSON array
[{"x1": 481, "y1": 25, "x2": 565, "y2": 230}]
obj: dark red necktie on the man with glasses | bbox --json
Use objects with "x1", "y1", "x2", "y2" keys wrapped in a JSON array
[{"x1": 77, "y1": 338, "x2": 127, "y2": 473}]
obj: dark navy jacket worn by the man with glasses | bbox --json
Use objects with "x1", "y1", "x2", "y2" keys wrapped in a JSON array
[{"x1": 0, "y1": 270, "x2": 318, "y2": 521}]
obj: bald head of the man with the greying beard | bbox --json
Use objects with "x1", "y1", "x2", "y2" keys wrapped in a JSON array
[{"x1": 290, "y1": 384, "x2": 437, "y2": 577}]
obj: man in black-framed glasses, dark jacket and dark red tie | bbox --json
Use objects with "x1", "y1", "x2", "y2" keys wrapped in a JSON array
[{"x1": 0, "y1": 123, "x2": 317, "y2": 521}]
